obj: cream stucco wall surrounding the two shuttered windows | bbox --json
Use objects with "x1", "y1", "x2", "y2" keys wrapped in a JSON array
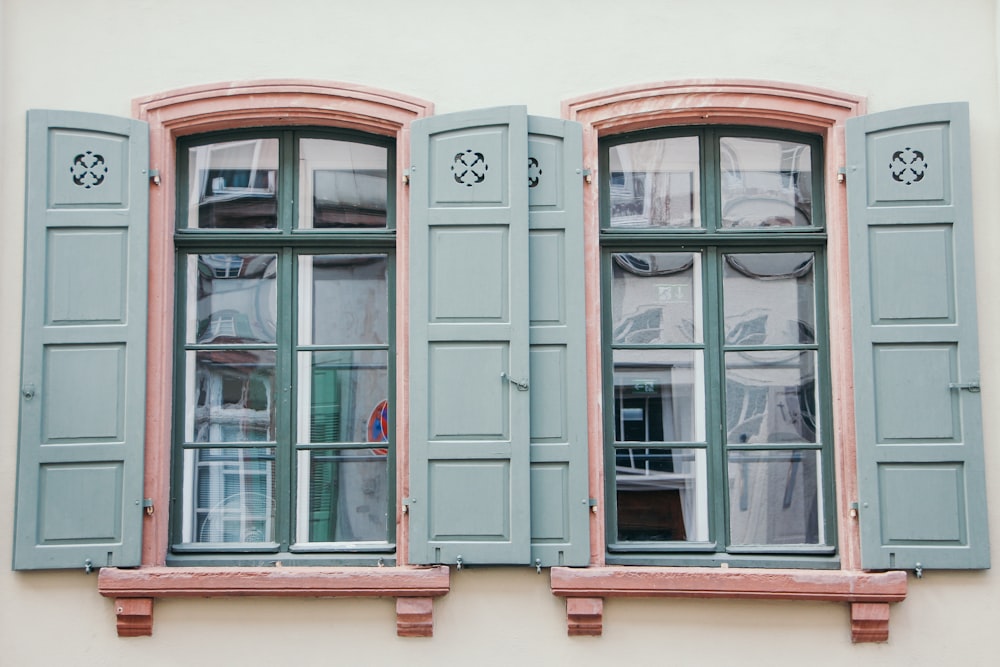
[{"x1": 0, "y1": 0, "x2": 1000, "y2": 667}]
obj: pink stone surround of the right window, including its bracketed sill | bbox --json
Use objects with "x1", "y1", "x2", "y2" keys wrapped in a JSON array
[{"x1": 552, "y1": 80, "x2": 906, "y2": 641}]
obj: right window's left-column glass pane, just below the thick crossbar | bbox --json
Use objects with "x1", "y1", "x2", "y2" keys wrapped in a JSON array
[{"x1": 611, "y1": 252, "x2": 702, "y2": 345}]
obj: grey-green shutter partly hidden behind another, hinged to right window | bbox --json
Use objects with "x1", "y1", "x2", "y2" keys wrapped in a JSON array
[{"x1": 527, "y1": 116, "x2": 590, "y2": 566}]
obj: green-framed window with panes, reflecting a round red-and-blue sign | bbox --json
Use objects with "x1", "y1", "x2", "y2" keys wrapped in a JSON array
[{"x1": 168, "y1": 128, "x2": 396, "y2": 565}]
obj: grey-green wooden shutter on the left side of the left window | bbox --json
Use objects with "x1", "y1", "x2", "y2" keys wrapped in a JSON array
[{"x1": 14, "y1": 111, "x2": 149, "y2": 570}]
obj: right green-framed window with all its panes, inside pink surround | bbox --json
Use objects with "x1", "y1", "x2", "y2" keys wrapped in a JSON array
[{"x1": 598, "y1": 126, "x2": 838, "y2": 568}]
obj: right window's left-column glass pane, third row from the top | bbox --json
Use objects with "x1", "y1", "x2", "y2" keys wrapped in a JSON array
[{"x1": 614, "y1": 350, "x2": 705, "y2": 442}]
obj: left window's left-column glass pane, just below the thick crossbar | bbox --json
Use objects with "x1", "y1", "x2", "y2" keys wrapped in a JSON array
[{"x1": 187, "y1": 254, "x2": 278, "y2": 345}]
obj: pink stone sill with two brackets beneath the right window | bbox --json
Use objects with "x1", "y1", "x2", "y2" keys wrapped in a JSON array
[{"x1": 552, "y1": 567, "x2": 907, "y2": 643}]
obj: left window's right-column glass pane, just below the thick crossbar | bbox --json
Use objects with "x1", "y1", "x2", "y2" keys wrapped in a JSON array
[{"x1": 299, "y1": 255, "x2": 389, "y2": 345}]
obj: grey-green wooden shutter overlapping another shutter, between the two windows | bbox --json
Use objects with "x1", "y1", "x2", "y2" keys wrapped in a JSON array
[{"x1": 405, "y1": 107, "x2": 530, "y2": 564}]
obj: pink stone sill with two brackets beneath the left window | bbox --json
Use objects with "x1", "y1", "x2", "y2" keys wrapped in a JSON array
[{"x1": 97, "y1": 566, "x2": 451, "y2": 637}]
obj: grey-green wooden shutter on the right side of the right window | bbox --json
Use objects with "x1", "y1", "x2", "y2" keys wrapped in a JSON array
[{"x1": 847, "y1": 104, "x2": 989, "y2": 569}]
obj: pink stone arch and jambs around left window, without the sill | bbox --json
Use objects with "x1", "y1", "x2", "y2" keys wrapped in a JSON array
[{"x1": 133, "y1": 81, "x2": 433, "y2": 565}]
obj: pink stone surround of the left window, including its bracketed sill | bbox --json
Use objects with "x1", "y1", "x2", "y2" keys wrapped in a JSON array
[{"x1": 98, "y1": 80, "x2": 449, "y2": 636}]
